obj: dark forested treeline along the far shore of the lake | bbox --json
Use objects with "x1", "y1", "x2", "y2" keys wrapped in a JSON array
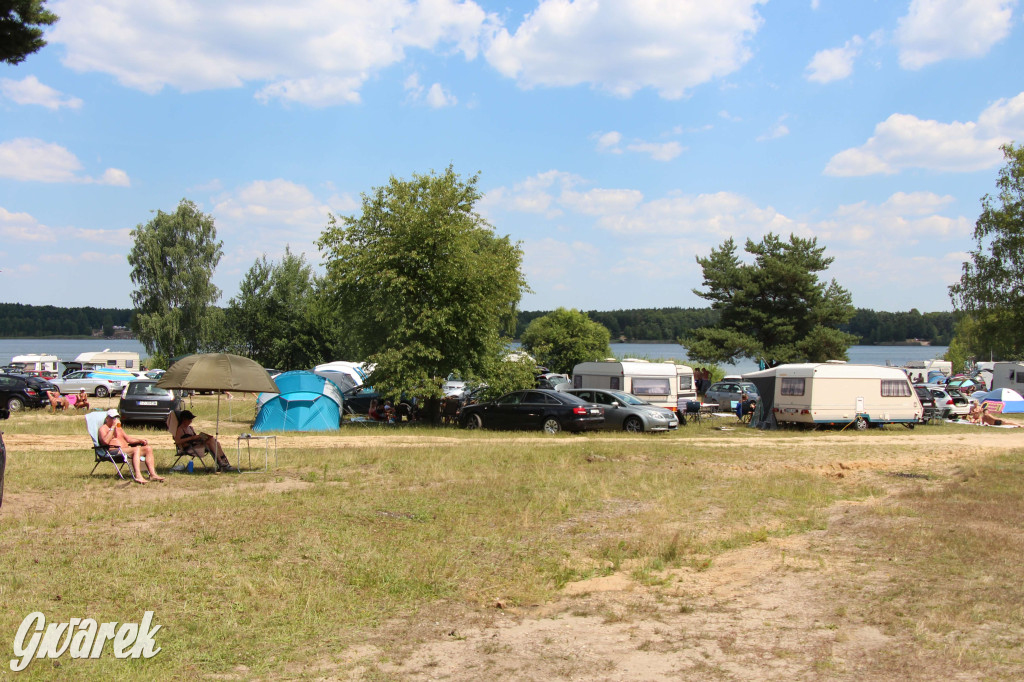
[{"x1": 0, "y1": 303, "x2": 954, "y2": 346}]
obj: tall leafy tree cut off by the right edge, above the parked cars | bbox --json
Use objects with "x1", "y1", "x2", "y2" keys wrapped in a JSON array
[{"x1": 949, "y1": 144, "x2": 1024, "y2": 359}]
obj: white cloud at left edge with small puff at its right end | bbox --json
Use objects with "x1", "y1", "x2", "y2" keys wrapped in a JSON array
[{"x1": 0, "y1": 137, "x2": 130, "y2": 186}]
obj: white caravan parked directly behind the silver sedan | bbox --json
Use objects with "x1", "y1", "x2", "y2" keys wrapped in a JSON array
[{"x1": 572, "y1": 359, "x2": 679, "y2": 412}]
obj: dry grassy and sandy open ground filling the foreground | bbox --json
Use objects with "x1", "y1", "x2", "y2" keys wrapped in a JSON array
[{"x1": 0, "y1": 397, "x2": 1024, "y2": 681}]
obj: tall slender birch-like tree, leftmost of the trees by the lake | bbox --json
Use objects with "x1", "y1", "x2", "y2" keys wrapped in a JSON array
[{"x1": 128, "y1": 199, "x2": 223, "y2": 364}]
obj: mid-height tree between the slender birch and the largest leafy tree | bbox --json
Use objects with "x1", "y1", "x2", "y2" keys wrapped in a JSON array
[{"x1": 228, "y1": 247, "x2": 325, "y2": 371}]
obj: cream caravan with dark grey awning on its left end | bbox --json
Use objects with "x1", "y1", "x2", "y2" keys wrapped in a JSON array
[{"x1": 743, "y1": 363, "x2": 924, "y2": 429}]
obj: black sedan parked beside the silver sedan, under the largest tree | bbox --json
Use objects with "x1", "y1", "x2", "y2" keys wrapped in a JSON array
[{"x1": 459, "y1": 388, "x2": 604, "y2": 433}]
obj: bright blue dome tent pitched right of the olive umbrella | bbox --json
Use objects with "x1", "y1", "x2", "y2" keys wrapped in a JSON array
[{"x1": 253, "y1": 371, "x2": 342, "y2": 431}]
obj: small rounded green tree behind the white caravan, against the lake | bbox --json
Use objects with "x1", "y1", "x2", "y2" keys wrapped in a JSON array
[{"x1": 521, "y1": 308, "x2": 611, "y2": 374}]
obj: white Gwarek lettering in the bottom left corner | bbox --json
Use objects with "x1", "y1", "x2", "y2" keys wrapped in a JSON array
[{"x1": 10, "y1": 611, "x2": 163, "y2": 673}]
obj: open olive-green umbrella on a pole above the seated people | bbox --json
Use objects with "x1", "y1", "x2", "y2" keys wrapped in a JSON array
[{"x1": 157, "y1": 353, "x2": 281, "y2": 435}]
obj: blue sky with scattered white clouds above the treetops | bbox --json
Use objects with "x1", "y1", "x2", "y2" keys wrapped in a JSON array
[{"x1": 0, "y1": 0, "x2": 1024, "y2": 311}]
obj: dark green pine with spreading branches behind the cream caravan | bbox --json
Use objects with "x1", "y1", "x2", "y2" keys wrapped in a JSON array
[{"x1": 680, "y1": 233, "x2": 856, "y2": 364}]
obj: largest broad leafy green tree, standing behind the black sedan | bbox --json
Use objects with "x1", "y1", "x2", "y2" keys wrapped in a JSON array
[{"x1": 318, "y1": 167, "x2": 526, "y2": 397}]
